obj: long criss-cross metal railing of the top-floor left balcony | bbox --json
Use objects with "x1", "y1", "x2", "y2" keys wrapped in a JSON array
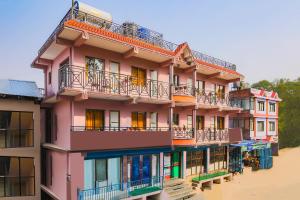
[{"x1": 59, "y1": 65, "x2": 170, "y2": 99}]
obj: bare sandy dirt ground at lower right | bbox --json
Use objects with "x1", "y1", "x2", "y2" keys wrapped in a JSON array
[{"x1": 203, "y1": 147, "x2": 300, "y2": 200}]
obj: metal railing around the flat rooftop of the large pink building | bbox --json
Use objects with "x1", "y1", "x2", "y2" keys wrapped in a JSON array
[{"x1": 39, "y1": 9, "x2": 236, "y2": 71}]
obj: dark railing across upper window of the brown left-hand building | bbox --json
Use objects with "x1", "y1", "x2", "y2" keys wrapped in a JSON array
[{"x1": 0, "y1": 129, "x2": 33, "y2": 148}]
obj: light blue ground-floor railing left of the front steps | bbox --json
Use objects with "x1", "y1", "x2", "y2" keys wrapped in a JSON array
[{"x1": 78, "y1": 177, "x2": 163, "y2": 200}]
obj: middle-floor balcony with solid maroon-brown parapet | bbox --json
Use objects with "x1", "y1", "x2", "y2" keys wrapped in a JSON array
[{"x1": 70, "y1": 126, "x2": 172, "y2": 151}]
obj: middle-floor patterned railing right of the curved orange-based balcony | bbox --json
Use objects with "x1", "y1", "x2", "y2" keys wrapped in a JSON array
[{"x1": 196, "y1": 128, "x2": 229, "y2": 143}]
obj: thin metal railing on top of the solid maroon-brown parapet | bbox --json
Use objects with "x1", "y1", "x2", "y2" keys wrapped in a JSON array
[{"x1": 71, "y1": 126, "x2": 170, "y2": 132}]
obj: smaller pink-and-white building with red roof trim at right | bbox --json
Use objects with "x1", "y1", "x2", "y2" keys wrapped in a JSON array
[{"x1": 229, "y1": 88, "x2": 281, "y2": 154}]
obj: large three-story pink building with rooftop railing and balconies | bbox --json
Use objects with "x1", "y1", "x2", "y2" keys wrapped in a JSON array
[{"x1": 32, "y1": 3, "x2": 243, "y2": 199}]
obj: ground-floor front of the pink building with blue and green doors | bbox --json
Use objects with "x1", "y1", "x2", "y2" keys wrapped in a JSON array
[{"x1": 74, "y1": 145, "x2": 229, "y2": 199}]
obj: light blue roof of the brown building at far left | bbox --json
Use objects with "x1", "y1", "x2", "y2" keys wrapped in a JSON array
[{"x1": 0, "y1": 79, "x2": 42, "y2": 99}]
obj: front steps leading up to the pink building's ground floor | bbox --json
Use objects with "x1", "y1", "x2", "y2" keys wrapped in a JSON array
[{"x1": 163, "y1": 179, "x2": 203, "y2": 200}]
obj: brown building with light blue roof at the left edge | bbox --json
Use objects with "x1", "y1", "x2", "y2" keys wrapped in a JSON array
[{"x1": 0, "y1": 80, "x2": 42, "y2": 200}]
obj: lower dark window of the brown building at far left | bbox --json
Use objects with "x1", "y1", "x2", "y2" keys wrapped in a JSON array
[{"x1": 0, "y1": 157, "x2": 35, "y2": 197}]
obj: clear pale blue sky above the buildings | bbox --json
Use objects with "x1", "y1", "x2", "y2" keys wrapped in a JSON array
[{"x1": 0, "y1": 0, "x2": 300, "y2": 86}]
